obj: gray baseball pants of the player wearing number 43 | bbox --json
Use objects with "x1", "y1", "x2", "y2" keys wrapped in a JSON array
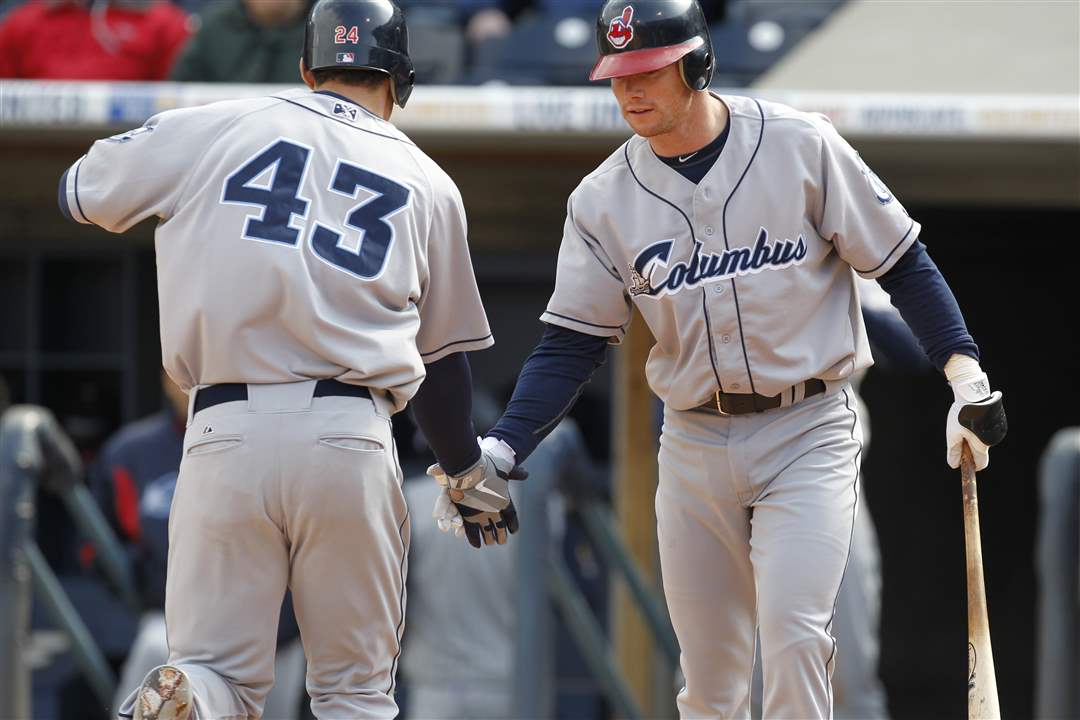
[{"x1": 121, "y1": 381, "x2": 409, "y2": 720}]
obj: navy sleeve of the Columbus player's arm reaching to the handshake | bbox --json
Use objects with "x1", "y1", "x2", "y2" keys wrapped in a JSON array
[{"x1": 487, "y1": 325, "x2": 608, "y2": 464}]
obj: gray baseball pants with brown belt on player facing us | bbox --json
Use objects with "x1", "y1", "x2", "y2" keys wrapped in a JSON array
[{"x1": 656, "y1": 385, "x2": 862, "y2": 720}]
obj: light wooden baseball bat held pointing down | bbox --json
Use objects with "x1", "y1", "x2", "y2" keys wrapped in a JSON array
[{"x1": 960, "y1": 441, "x2": 1001, "y2": 720}]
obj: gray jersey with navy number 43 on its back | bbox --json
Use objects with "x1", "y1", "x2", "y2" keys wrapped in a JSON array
[{"x1": 60, "y1": 90, "x2": 494, "y2": 409}]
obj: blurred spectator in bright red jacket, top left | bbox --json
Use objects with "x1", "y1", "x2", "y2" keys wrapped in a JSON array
[{"x1": 0, "y1": 0, "x2": 191, "y2": 80}]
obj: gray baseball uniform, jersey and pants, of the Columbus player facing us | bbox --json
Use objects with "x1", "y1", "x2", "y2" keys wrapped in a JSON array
[{"x1": 542, "y1": 96, "x2": 919, "y2": 718}]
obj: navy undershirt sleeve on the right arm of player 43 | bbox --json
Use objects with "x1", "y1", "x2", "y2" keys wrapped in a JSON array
[{"x1": 410, "y1": 353, "x2": 480, "y2": 475}]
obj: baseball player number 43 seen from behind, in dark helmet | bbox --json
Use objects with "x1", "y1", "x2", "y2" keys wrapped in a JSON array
[{"x1": 59, "y1": 0, "x2": 524, "y2": 720}]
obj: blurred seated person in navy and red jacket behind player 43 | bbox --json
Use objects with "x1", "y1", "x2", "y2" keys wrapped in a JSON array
[{"x1": 87, "y1": 372, "x2": 305, "y2": 720}]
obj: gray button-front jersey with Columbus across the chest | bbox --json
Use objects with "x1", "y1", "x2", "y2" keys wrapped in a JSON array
[{"x1": 541, "y1": 96, "x2": 919, "y2": 409}]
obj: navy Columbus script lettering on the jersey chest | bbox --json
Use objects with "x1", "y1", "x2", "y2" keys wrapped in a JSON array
[{"x1": 630, "y1": 228, "x2": 807, "y2": 297}]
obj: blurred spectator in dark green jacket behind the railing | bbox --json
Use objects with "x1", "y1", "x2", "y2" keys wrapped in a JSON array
[{"x1": 173, "y1": 0, "x2": 311, "y2": 84}]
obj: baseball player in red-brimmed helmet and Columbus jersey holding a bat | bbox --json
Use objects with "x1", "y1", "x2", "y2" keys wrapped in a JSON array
[{"x1": 427, "y1": 0, "x2": 1004, "y2": 718}]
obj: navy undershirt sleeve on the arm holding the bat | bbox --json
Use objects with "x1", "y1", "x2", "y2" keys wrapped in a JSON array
[{"x1": 878, "y1": 241, "x2": 978, "y2": 370}]
